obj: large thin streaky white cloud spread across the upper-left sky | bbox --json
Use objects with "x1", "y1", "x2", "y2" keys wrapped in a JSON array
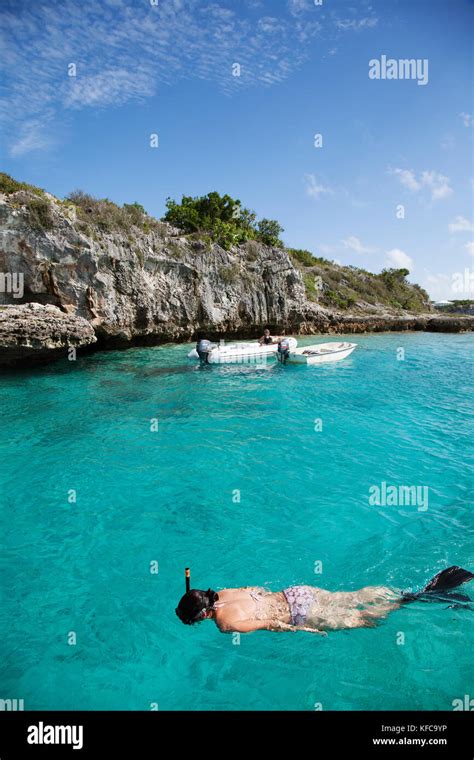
[{"x1": 0, "y1": 0, "x2": 329, "y2": 155}]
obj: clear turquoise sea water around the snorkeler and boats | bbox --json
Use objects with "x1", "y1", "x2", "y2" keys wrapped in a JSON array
[{"x1": 0, "y1": 333, "x2": 474, "y2": 710}]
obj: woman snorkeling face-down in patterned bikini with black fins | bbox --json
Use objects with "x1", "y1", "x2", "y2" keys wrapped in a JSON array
[{"x1": 176, "y1": 565, "x2": 474, "y2": 635}]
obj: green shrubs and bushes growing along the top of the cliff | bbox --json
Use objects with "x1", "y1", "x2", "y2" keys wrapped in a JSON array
[{"x1": 0, "y1": 173, "x2": 432, "y2": 313}]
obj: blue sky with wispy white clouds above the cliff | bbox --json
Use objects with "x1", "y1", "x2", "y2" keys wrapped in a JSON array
[{"x1": 0, "y1": 0, "x2": 474, "y2": 299}]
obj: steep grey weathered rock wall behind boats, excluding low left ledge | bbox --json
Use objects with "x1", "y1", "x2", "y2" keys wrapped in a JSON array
[{"x1": 0, "y1": 193, "x2": 312, "y2": 345}]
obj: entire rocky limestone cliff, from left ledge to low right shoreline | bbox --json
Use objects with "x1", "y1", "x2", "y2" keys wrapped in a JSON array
[{"x1": 0, "y1": 190, "x2": 474, "y2": 368}]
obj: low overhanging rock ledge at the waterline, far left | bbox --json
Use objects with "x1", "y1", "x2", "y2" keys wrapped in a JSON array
[{"x1": 0, "y1": 304, "x2": 96, "y2": 367}]
